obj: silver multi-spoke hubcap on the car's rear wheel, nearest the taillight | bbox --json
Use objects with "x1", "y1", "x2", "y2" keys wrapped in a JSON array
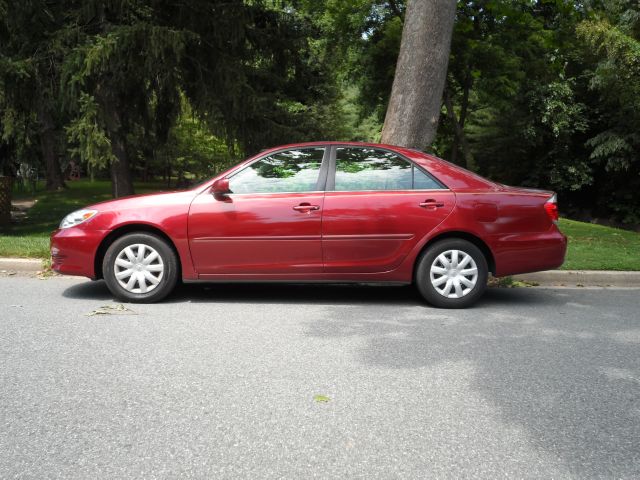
[{"x1": 430, "y1": 250, "x2": 478, "y2": 298}]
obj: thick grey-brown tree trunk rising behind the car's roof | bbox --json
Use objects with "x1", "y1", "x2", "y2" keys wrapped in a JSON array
[{"x1": 382, "y1": 0, "x2": 456, "y2": 150}]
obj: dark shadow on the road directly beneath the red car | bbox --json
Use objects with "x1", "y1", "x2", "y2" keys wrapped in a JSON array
[{"x1": 63, "y1": 280, "x2": 548, "y2": 308}]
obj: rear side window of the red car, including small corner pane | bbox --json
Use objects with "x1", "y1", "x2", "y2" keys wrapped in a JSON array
[{"x1": 335, "y1": 147, "x2": 443, "y2": 192}]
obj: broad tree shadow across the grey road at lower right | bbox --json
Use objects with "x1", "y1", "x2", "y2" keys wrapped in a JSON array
[{"x1": 306, "y1": 289, "x2": 640, "y2": 478}]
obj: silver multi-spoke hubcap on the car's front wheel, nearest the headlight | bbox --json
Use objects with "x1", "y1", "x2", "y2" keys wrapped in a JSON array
[{"x1": 114, "y1": 243, "x2": 164, "y2": 293}]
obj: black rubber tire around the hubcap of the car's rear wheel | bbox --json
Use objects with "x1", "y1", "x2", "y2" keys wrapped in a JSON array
[{"x1": 415, "y1": 238, "x2": 489, "y2": 308}]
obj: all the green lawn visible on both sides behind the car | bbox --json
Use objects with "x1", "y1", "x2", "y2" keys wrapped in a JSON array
[{"x1": 0, "y1": 184, "x2": 640, "y2": 270}]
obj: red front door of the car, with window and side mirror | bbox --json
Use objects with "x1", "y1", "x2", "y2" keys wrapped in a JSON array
[{"x1": 189, "y1": 147, "x2": 329, "y2": 278}]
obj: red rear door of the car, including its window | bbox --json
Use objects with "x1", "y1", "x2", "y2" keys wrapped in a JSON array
[{"x1": 322, "y1": 146, "x2": 455, "y2": 273}]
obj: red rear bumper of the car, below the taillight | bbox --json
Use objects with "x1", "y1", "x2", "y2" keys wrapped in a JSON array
[{"x1": 491, "y1": 229, "x2": 567, "y2": 277}]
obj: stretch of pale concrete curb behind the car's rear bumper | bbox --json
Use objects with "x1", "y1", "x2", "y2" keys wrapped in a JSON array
[{"x1": 513, "y1": 270, "x2": 640, "y2": 287}]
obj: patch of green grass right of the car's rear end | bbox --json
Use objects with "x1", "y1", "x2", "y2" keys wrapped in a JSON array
[{"x1": 560, "y1": 219, "x2": 640, "y2": 270}]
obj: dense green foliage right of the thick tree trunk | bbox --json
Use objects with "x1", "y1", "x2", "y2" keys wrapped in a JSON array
[{"x1": 436, "y1": 0, "x2": 640, "y2": 224}]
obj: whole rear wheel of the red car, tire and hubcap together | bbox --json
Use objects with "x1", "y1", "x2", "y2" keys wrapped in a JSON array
[{"x1": 416, "y1": 238, "x2": 489, "y2": 308}]
